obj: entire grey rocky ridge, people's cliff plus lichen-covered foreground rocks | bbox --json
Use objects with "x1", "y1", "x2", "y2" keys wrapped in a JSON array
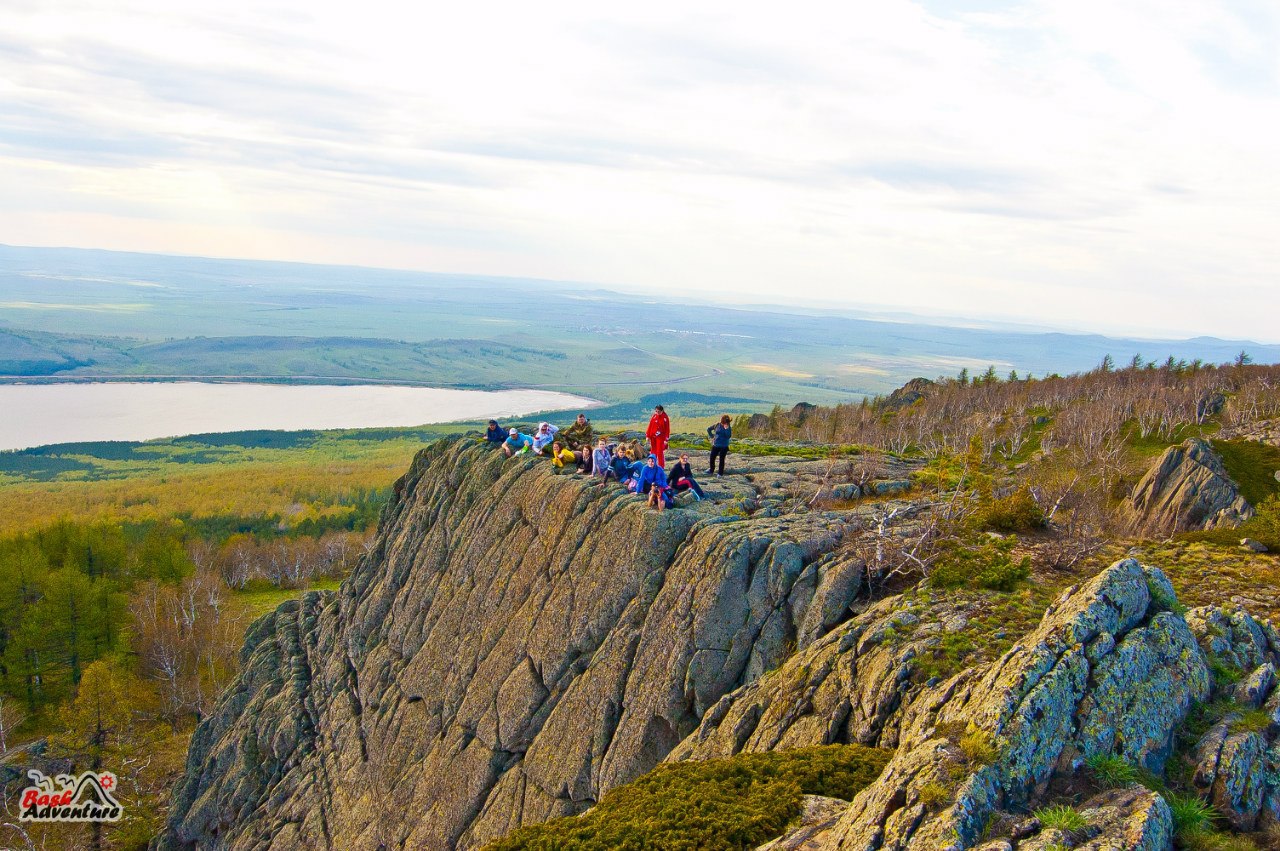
[{"x1": 157, "y1": 441, "x2": 1280, "y2": 851}]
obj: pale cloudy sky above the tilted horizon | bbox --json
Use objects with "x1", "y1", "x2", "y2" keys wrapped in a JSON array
[{"x1": 0, "y1": 0, "x2": 1280, "y2": 342}]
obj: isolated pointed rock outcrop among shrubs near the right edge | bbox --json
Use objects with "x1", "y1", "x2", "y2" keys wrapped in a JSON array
[{"x1": 1124, "y1": 438, "x2": 1253, "y2": 536}]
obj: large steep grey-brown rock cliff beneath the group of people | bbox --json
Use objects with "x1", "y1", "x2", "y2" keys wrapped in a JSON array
[{"x1": 157, "y1": 441, "x2": 901, "y2": 850}]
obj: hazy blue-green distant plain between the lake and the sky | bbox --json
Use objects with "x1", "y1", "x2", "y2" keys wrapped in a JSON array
[{"x1": 10, "y1": 246, "x2": 1280, "y2": 410}]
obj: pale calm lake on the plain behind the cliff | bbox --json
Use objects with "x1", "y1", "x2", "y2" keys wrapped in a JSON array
[{"x1": 0, "y1": 381, "x2": 598, "y2": 449}]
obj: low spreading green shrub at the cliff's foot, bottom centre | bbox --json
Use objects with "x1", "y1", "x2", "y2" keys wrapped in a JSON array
[{"x1": 486, "y1": 745, "x2": 891, "y2": 851}]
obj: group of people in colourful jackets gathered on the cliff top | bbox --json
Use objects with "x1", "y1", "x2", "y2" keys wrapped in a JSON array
[{"x1": 484, "y1": 404, "x2": 733, "y2": 511}]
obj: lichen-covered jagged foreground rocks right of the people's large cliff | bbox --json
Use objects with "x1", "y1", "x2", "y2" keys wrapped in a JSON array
[{"x1": 668, "y1": 559, "x2": 1218, "y2": 851}]
